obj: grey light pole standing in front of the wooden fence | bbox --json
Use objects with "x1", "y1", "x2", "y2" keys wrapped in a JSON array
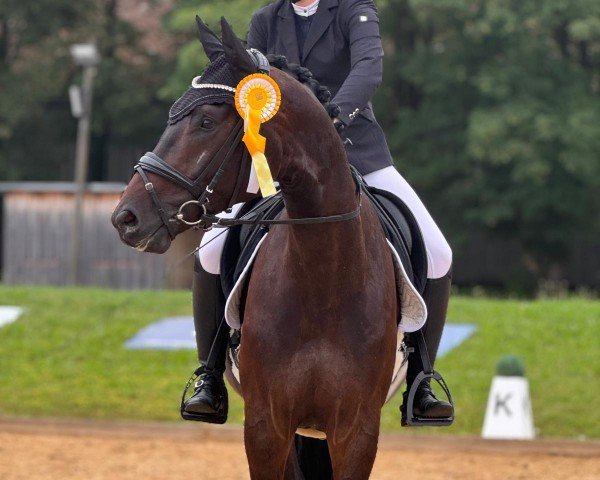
[{"x1": 69, "y1": 43, "x2": 100, "y2": 284}]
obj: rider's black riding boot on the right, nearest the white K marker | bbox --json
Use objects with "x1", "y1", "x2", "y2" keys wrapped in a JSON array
[{"x1": 400, "y1": 270, "x2": 454, "y2": 425}]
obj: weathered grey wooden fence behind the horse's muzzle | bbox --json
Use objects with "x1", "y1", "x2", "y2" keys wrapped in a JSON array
[{"x1": 0, "y1": 182, "x2": 198, "y2": 288}]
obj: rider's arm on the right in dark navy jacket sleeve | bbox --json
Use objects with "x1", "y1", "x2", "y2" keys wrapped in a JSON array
[{"x1": 332, "y1": 0, "x2": 383, "y2": 125}]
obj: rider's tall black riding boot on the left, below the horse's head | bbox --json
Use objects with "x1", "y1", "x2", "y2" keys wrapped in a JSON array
[{"x1": 181, "y1": 258, "x2": 229, "y2": 423}]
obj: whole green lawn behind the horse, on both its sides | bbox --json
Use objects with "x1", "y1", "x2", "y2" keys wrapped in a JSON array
[{"x1": 0, "y1": 286, "x2": 600, "y2": 438}]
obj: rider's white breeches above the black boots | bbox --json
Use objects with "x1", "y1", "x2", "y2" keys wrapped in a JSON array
[{"x1": 198, "y1": 166, "x2": 452, "y2": 278}]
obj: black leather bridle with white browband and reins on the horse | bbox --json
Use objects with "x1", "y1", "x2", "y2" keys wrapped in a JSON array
[{"x1": 134, "y1": 49, "x2": 361, "y2": 240}]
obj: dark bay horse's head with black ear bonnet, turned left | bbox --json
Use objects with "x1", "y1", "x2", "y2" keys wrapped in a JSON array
[{"x1": 112, "y1": 18, "x2": 284, "y2": 253}]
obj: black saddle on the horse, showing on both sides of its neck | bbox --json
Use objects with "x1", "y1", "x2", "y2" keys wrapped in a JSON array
[{"x1": 221, "y1": 167, "x2": 427, "y2": 322}]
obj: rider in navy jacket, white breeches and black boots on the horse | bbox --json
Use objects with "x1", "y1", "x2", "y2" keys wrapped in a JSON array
[{"x1": 184, "y1": 0, "x2": 453, "y2": 424}]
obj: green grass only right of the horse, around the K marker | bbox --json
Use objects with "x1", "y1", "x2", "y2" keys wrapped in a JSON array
[{"x1": 383, "y1": 297, "x2": 600, "y2": 438}]
